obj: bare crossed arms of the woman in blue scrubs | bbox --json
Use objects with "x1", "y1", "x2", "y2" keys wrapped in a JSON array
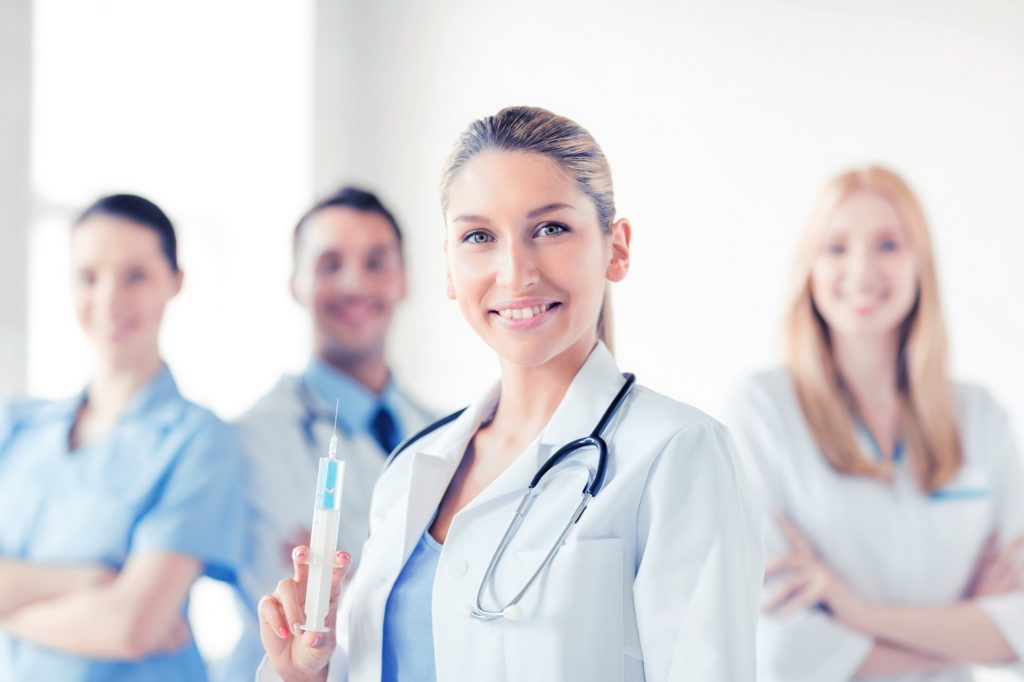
[{"x1": 0, "y1": 552, "x2": 201, "y2": 660}]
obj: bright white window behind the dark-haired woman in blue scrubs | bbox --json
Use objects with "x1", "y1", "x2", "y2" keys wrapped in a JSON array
[{"x1": 28, "y1": 0, "x2": 313, "y2": 416}]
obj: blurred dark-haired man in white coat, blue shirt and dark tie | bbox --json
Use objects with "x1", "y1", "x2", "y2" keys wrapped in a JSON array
[{"x1": 229, "y1": 187, "x2": 431, "y2": 680}]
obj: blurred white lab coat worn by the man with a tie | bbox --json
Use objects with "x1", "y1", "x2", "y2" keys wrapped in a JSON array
[{"x1": 229, "y1": 376, "x2": 433, "y2": 679}]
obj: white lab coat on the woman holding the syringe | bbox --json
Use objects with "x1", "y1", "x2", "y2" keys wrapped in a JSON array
[{"x1": 260, "y1": 344, "x2": 763, "y2": 682}]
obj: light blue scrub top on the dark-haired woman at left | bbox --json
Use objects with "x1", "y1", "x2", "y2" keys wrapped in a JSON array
[{"x1": 0, "y1": 367, "x2": 246, "y2": 682}]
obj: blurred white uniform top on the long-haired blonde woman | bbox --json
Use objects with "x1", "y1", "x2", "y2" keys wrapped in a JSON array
[{"x1": 728, "y1": 370, "x2": 1024, "y2": 682}]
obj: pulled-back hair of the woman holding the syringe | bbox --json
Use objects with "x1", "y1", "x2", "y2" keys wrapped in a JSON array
[{"x1": 441, "y1": 106, "x2": 615, "y2": 352}]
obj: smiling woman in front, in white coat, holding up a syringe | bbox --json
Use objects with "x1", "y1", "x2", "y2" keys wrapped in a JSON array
[{"x1": 259, "y1": 108, "x2": 763, "y2": 682}]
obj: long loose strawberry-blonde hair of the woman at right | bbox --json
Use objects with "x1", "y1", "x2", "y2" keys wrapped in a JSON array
[{"x1": 785, "y1": 166, "x2": 964, "y2": 491}]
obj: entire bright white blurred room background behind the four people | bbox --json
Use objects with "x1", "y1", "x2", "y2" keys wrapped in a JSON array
[{"x1": 0, "y1": 0, "x2": 1024, "y2": 679}]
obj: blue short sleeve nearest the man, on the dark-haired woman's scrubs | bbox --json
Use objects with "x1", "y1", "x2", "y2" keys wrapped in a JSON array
[{"x1": 131, "y1": 418, "x2": 248, "y2": 583}]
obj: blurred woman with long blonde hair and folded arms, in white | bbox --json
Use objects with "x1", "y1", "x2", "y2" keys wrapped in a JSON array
[{"x1": 729, "y1": 168, "x2": 1024, "y2": 682}]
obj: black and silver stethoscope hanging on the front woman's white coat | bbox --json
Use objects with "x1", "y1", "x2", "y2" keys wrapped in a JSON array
[{"x1": 469, "y1": 374, "x2": 636, "y2": 621}]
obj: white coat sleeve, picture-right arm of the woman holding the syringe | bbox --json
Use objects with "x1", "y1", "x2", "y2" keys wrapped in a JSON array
[{"x1": 633, "y1": 420, "x2": 764, "y2": 682}]
